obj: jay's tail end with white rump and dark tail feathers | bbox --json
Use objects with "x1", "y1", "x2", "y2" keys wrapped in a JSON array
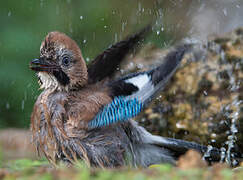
[{"x1": 131, "y1": 121, "x2": 222, "y2": 167}]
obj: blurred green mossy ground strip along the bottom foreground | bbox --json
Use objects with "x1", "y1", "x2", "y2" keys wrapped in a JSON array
[{"x1": 0, "y1": 159, "x2": 243, "y2": 180}]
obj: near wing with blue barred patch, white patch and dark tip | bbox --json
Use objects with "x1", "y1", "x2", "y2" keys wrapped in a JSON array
[{"x1": 89, "y1": 45, "x2": 190, "y2": 128}]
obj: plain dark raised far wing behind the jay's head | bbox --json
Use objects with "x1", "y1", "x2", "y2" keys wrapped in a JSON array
[{"x1": 88, "y1": 25, "x2": 151, "y2": 83}]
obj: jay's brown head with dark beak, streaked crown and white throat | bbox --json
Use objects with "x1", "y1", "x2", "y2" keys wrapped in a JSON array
[{"x1": 30, "y1": 32, "x2": 88, "y2": 90}]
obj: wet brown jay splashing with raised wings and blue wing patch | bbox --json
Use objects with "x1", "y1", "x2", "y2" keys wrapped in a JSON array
[{"x1": 30, "y1": 25, "x2": 221, "y2": 168}]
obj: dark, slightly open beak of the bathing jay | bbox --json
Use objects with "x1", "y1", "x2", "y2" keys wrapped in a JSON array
[{"x1": 30, "y1": 57, "x2": 58, "y2": 72}]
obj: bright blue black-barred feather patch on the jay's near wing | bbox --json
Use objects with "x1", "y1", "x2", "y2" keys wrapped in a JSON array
[{"x1": 88, "y1": 96, "x2": 143, "y2": 128}]
